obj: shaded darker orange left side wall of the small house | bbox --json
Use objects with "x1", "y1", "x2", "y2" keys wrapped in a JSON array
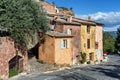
[{"x1": 38, "y1": 36, "x2": 55, "y2": 64}]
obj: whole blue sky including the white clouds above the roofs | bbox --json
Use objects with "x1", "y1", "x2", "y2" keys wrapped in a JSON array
[{"x1": 46, "y1": 0, "x2": 120, "y2": 31}]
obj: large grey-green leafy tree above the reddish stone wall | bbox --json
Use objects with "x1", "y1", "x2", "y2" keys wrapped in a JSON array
[{"x1": 0, "y1": 0, "x2": 49, "y2": 48}]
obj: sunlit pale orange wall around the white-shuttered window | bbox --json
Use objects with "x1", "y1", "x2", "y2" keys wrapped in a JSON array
[{"x1": 55, "y1": 38, "x2": 73, "y2": 64}]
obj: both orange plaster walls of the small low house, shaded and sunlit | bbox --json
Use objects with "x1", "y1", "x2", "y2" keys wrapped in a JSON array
[{"x1": 38, "y1": 31, "x2": 73, "y2": 64}]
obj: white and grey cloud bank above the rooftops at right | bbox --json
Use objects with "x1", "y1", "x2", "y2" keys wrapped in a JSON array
[{"x1": 76, "y1": 12, "x2": 120, "y2": 31}]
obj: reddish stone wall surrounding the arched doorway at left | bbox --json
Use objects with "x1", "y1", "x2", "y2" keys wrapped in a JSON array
[{"x1": 0, "y1": 37, "x2": 28, "y2": 79}]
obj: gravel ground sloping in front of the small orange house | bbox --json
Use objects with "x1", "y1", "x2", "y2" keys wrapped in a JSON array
[{"x1": 28, "y1": 57, "x2": 70, "y2": 73}]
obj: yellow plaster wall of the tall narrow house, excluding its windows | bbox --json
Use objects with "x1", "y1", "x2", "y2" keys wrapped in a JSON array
[{"x1": 80, "y1": 24, "x2": 96, "y2": 61}]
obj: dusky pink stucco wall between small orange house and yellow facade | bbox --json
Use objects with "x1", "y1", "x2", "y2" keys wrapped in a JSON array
[{"x1": 55, "y1": 24, "x2": 81, "y2": 58}]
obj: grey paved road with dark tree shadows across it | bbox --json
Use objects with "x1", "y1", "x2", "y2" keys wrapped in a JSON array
[{"x1": 11, "y1": 55, "x2": 120, "y2": 80}]
